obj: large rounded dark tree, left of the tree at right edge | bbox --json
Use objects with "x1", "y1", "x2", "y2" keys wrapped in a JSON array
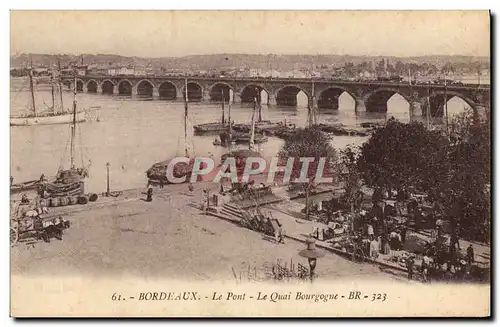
[{"x1": 358, "y1": 119, "x2": 448, "y2": 199}]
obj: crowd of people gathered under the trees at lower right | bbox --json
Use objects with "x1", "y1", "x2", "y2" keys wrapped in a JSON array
[{"x1": 315, "y1": 187, "x2": 484, "y2": 281}]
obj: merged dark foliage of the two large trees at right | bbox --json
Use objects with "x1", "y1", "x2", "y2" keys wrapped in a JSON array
[{"x1": 358, "y1": 115, "x2": 491, "y2": 241}]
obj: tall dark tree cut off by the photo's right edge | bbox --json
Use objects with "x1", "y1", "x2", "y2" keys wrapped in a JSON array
[{"x1": 442, "y1": 110, "x2": 491, "y2": 243}]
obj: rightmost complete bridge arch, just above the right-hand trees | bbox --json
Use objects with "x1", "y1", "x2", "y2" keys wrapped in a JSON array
[{"x1": 422, "y1": 90, "x2": 476, "y2": 117}]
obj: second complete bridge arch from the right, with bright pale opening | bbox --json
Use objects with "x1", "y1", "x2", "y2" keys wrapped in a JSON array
[{"x1": 364, "y1": 87, "x2": 411, "y2": 117}]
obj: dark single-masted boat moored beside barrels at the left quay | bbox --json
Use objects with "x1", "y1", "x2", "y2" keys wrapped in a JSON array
[{"x1": 39, "y1": 75, "x2": 90, "y2": 197}]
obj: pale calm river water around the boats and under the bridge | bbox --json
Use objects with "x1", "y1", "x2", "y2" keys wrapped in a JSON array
[{"x1": 10, "y1": 79, "x2": 472, "y2": 192}]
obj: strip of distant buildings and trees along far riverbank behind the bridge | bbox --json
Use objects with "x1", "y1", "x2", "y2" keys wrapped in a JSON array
[{"x1": 11, "y1": 59, "x2": 490, "y2": 82}]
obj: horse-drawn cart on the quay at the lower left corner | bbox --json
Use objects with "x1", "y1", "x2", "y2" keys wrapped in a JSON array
[{"x1": 10, "y1": 214, "x2": 70, "y2": 246}]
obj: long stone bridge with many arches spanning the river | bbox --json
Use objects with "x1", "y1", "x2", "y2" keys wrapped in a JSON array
[{"x1": 63, "y1": 76, "x2": 491, "y2": 117}]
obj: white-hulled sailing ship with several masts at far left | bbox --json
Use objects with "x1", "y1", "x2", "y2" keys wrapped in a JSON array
[{"x1": 10, "y1": 59, "x2": 86, "y2": 126}]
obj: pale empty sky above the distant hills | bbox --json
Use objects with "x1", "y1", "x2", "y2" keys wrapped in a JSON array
[{"x1": 10, "y1": 11, "x2": 490, "y2": 57}]
